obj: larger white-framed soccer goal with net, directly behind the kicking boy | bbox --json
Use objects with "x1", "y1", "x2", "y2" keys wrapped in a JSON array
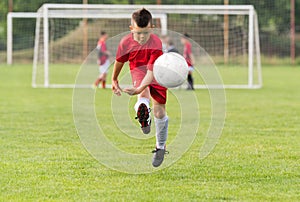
[{"x1": 32, "y1": 4, "x2": 262, "y2": 88}]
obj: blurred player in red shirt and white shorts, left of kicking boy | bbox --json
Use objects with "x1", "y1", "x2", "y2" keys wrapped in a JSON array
[{"x1": 94, "y1": 31, "x2": 110, "y2": 88}]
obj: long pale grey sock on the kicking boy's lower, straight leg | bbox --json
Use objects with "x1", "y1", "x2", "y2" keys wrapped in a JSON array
[{"x1": 154, "y1": 115, "x2": 169, "y2": 149}]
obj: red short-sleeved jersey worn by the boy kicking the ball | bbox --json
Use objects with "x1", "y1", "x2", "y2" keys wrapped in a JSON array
[{"x1": 116, "y1": 33, "x2": 163, "y2": 72}]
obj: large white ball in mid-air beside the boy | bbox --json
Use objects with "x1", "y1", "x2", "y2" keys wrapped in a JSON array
[{"x1": 153, "y1": 52, "x2": 189, "y2": 88}]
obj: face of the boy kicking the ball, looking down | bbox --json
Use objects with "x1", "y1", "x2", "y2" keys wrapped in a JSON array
[{"x1": 130, "y1": 21, "x2": 152, "y2": 45}]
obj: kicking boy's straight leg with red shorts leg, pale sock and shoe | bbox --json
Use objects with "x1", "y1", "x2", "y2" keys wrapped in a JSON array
[{"x1": 150, "y1": 86, "x2": 169, "y2": 167}]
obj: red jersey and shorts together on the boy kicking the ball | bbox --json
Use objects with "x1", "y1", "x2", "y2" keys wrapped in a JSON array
[{"x1": 116, "y1": 33, "x2": 167, "y2": 104}]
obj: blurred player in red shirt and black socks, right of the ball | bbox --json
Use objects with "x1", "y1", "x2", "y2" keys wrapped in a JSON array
[{"x1": 181, "y1": 33, "x2": 195, "y2": 90}]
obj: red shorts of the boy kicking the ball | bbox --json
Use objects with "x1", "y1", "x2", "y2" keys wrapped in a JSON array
[{"x1": 131, "y1": 70, "x2": 167, "y2": 104}]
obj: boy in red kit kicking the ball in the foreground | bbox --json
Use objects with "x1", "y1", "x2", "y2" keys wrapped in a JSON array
[{"x1": 112, "y1": 8, "x2": 168, "y2": 167}]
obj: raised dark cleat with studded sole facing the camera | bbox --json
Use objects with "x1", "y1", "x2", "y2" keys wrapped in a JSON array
[{"x1": 135, "y1": 103, "x2": 151, "y2": 134}]
